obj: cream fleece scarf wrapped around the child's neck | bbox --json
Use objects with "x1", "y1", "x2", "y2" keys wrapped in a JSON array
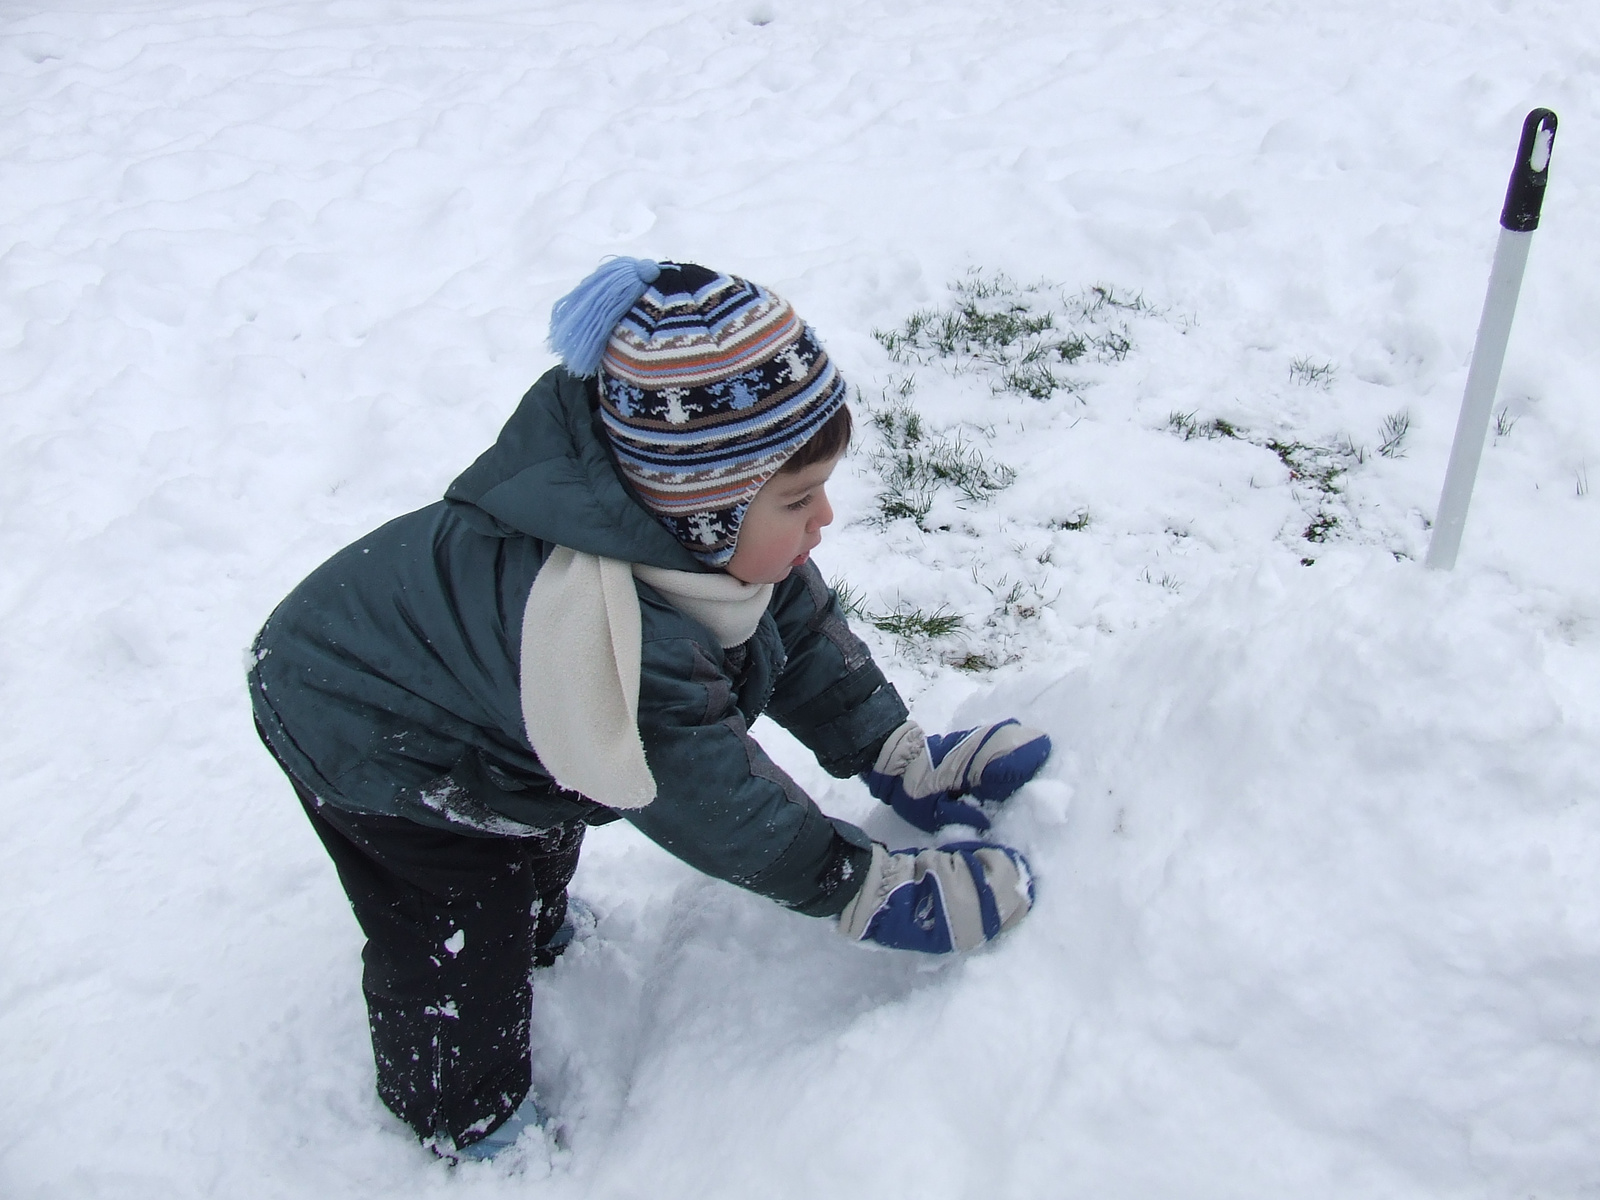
[{"x1": 522, "y1": 546, "x2": 773, "y2": 808}]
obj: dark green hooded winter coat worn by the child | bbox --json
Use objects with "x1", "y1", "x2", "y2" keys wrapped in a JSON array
[{"x1": 250, "y1": 368, "x2": 906, "y2": 915}]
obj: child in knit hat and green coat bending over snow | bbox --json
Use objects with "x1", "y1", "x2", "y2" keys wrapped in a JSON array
[{"x1": 250, "y1": 259, "x2": 1050, "y2": 1160}]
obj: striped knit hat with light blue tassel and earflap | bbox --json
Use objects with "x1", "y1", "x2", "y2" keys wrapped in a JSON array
[{"x1": 550, "y1": 258, "x2": 845, "y2": 566}]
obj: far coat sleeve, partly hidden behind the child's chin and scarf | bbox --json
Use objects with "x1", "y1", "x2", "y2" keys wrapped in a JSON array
[{"x1": 766, "y1": 562, "x2": 909, "y2": 779}]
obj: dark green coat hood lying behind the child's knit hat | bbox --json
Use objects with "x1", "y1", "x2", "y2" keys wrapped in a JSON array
[{"x1": 445, "y1": 366, "x2": 709, "y2": 573}]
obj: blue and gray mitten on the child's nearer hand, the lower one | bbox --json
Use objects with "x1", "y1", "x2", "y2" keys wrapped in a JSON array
[{"x1": 838, "y1": 842, "x2": 1034, "y2": 954}]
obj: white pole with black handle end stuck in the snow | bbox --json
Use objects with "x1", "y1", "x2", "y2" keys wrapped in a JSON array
[{"x1": 1427, "y1": 109, "x2": 1555, "y2": 571}]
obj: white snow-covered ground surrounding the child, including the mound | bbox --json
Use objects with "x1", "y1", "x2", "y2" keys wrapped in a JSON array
[{"x1": 0, "y1": 0, "x2": 1600, "y2": 1200}]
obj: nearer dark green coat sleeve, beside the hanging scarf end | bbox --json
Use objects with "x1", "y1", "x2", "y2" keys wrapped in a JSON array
[{"x1": 622, "y1": 624, "x2": 872, "y2": 917}]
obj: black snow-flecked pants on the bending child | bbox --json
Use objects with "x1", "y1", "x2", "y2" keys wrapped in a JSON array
[{"x1": 294, "y1": 782, "x2": 584, "y2": 1147}]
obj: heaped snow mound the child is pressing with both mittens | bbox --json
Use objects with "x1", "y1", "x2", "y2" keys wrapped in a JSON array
[{"x1": 524, "y1": 555, "x2": 1600, "y2": 1197}]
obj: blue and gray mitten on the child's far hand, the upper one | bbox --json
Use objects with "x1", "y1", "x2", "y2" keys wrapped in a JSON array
[{"x1": 866, "y1": 720, "x2": 1050, "y2": 834}]
